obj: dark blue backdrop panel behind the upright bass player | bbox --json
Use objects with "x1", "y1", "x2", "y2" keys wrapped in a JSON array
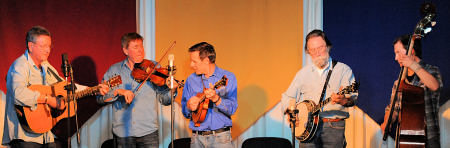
[{"x1": 323, "y1": 0, "x2": 450, "y2": 123}]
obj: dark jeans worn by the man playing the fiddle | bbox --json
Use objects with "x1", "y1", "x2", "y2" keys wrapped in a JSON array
[{"x1": 114, "y1": 131, "x2": 159, "y2": 148}]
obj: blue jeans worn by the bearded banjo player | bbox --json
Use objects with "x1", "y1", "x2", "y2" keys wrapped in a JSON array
[{"x1": 299, "y1": 120, "x2": 346, "y2": 148}]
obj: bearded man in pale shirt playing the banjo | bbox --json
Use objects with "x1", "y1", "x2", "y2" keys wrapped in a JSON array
[{"x1": 281, "y1": 30, "x2": 357, "y2": 147}]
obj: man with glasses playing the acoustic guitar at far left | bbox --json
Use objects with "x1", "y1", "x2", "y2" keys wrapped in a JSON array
[{"x1": 3, "y1": 26, "x2": 109, "y2": 148}]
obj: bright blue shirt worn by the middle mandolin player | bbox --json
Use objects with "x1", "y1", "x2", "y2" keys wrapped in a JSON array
[{"x1": 181, "y1": 66, "x2": 238, "y2": 131}]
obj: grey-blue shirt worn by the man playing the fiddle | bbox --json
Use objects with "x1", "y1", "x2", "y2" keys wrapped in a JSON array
[{"x1": 98, "y1": 59, "x2": 171, "y2": 137}]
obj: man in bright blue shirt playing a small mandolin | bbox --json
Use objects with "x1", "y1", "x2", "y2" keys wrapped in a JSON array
[{"x1": 181, "y1": 42, "x2": 238, "y2": 148}]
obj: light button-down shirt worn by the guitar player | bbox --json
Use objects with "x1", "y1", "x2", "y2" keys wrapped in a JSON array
[{"x1": 3, "y1": 50, "x2": 57, "y2": 144}]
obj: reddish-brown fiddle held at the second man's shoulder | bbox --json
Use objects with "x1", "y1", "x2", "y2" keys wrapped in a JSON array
[{"x1": 131, "y1": 59, "x2": 184, "y2": 88}]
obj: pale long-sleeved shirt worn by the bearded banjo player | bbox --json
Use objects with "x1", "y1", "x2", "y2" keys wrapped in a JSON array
[{"x1": 281, "y1": 58, "x2": 358, "y2": 119}]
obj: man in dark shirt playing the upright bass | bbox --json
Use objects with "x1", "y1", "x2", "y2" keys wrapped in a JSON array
[{"x1": 381, "y1": 35, "x2": 443, "y2": 148}]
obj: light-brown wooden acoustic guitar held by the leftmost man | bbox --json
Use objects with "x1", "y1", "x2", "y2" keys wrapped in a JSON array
[{"x1": 15, "y1": 75, "x2": 122, "y2": 134}]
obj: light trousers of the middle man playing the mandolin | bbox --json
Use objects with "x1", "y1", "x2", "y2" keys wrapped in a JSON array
[{"x1": 191, "y1": 131, "x2": 234, "y2": 148}]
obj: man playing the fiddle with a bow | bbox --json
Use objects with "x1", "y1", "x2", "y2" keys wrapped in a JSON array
[{"x1": 97, "y1": 33, "x2": 178, "y2": 148}]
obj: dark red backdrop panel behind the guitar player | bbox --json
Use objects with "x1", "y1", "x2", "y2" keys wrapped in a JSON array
[{"x1": 0, "y1": 0, "x2": 136, "y2": 93}]
